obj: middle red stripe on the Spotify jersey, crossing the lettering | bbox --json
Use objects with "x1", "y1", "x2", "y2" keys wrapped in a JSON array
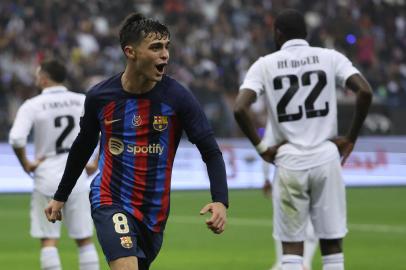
[{"x1": 132, "y1": 99, "x2": 150, "y2": 221}]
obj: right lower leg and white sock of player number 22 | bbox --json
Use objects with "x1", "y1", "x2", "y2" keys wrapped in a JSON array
[{"x1": 320, "y1": 239, "x2": 344, "y2": 270}]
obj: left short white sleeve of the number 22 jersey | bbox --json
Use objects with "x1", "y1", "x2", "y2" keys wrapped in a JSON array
[{"x1": 240, "y1": 57, "x2": 265, "y2": 96}]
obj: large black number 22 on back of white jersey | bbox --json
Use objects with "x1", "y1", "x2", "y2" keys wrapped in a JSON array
[{"x1": 273, "y1": 70, "x2": 329, "y2": 122}]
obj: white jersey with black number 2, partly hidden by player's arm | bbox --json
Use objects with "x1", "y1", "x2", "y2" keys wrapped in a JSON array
[{"x1": 9, "y1": 86, "x2": 88, "y2": 196}]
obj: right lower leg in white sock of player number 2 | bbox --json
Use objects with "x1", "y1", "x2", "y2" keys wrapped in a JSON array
[{"x1": 75, "y1": 237, "x2": 100, "y2": 270}]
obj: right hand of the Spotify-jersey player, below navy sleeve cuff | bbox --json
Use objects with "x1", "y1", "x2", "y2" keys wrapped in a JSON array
[{"x1": 200, "y1": 202, "x2": 227, "y2": 234}]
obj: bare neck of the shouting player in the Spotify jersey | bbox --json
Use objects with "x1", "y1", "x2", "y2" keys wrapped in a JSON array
[{"x1": 121, "y1": 66, "x2": 156, "y2": 94}]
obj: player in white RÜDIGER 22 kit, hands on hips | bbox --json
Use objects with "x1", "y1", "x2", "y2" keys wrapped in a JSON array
[{"x1": 234, "y1": 10, "x2": 372, "y2": 270}]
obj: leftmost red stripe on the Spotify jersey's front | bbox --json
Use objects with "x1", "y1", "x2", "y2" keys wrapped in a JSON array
[{"x1": 100, "y1": 102, "x2": 115, "y2": 205}]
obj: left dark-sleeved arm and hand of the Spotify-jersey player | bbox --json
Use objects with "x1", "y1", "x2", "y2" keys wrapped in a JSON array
[{"x1": 45, "y1": 93, "x2": 100, "y2": 222}]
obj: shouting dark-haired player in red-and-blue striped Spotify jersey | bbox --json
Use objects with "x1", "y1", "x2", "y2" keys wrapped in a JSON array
[{"x1": 45, "y1": 14, "x2": 228, "y2": 270}]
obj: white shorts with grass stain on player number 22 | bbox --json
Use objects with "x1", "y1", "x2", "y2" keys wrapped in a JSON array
[{"x1": 273, "y1": 159, "x2": 347, "y2": 242}]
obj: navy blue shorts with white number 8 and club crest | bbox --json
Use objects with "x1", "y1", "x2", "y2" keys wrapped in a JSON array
[{"x1": 92, "y1": 206, "x2": 163, "y2": 270}]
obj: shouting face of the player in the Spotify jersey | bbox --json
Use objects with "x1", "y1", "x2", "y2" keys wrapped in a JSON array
[{"x1": 129, "y1": 33, "x2": 170, "y2": 82}]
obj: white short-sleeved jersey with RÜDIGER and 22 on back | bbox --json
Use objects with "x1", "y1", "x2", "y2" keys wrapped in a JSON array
[{"x1": 240, "y1": 39, "x2": 359, "y2": 170}]
